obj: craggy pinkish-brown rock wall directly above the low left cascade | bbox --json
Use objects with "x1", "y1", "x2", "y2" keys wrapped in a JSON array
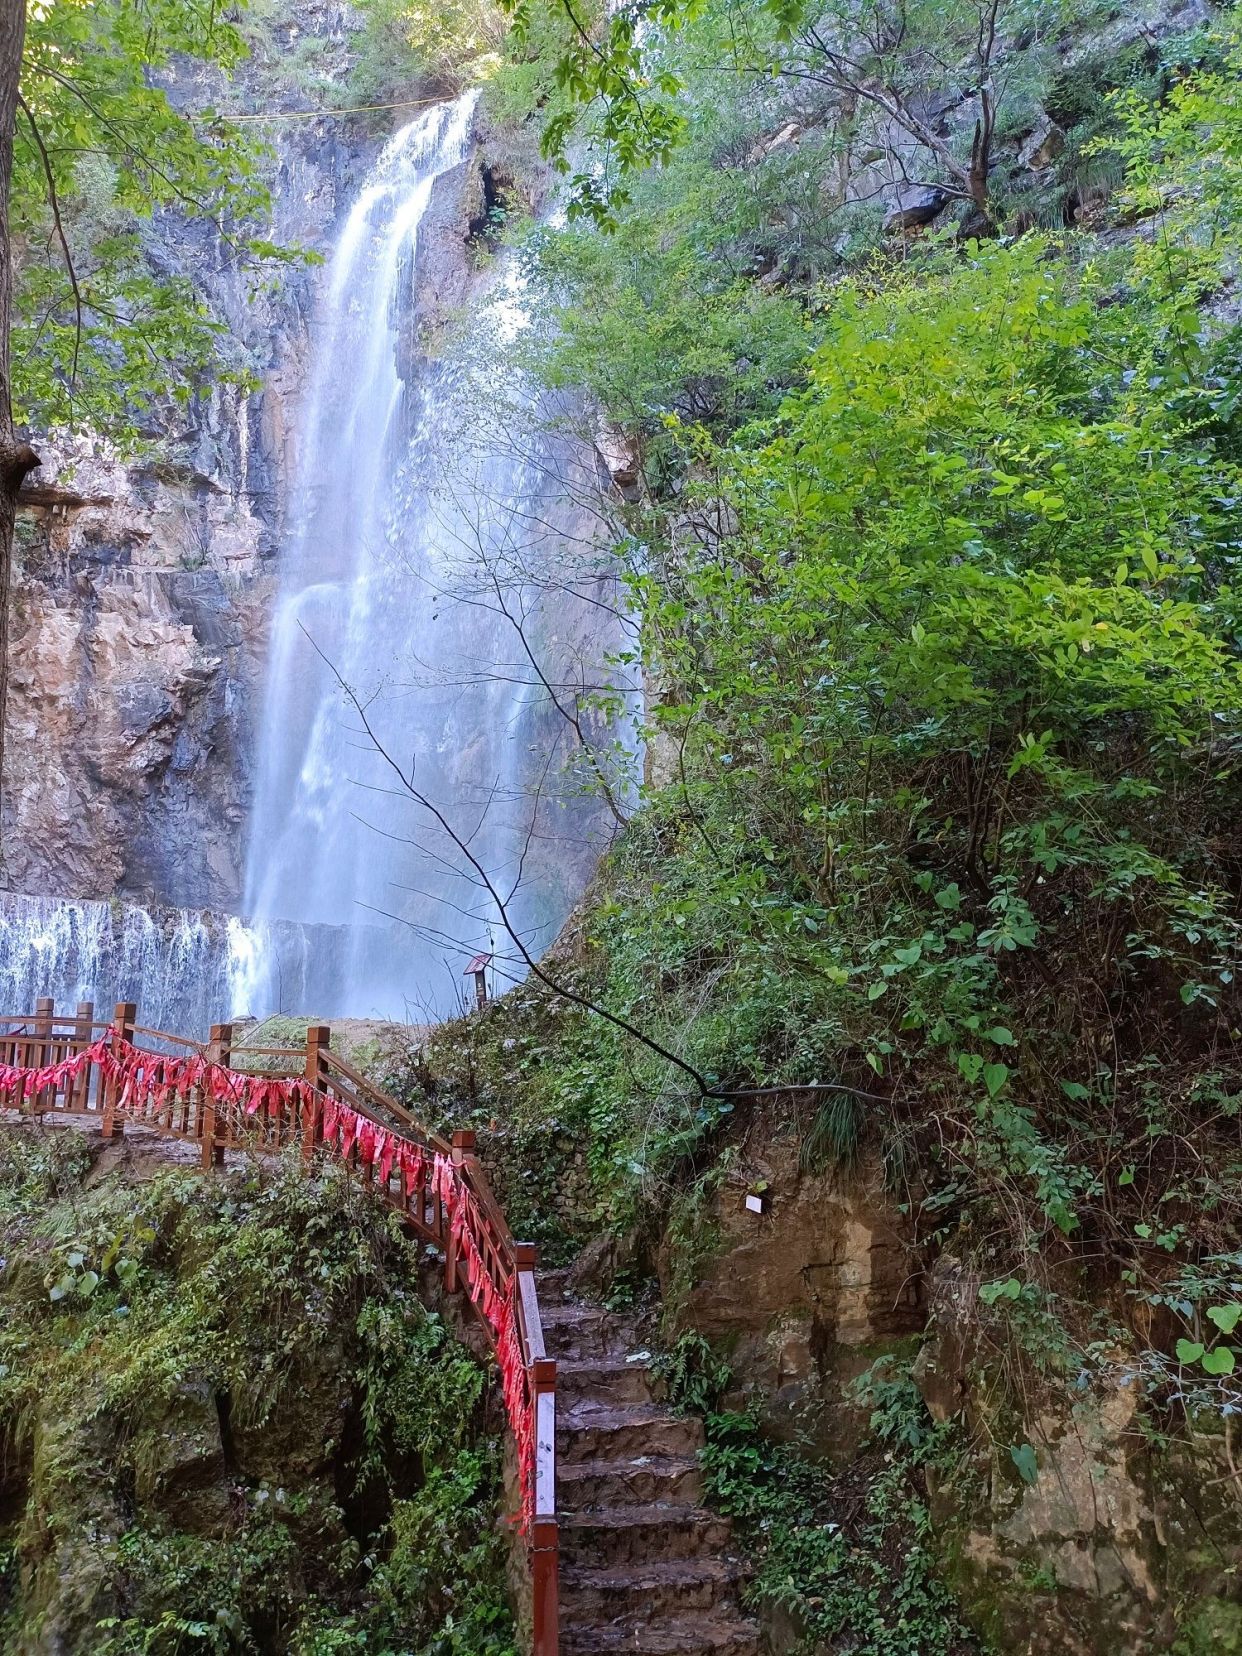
[{"x1": 5, "y1": 445, "x2": 268, "y2": 909}]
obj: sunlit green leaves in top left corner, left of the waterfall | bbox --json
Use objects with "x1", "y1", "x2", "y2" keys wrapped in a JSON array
[{"x1": 10, "y1": 0, "x2": 306, "y2": 442}]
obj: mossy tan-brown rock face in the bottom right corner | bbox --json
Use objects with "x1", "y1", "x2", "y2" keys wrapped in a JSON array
[{"x1": 914, "y1": 1255, "x2": 1242, "y2": 1656}]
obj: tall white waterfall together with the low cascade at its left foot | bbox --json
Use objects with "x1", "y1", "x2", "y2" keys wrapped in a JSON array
[{"x1": 0, "y1": 93, "x2": 616, "y2": 1035}]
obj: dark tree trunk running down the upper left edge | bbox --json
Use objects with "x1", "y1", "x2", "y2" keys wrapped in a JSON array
[{"x1": 0, "y1": 0, "x2": 40, "y2": 868}]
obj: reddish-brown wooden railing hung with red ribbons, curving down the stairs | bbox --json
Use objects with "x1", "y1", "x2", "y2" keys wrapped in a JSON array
[{"x1": 0, "y1": 1000, "x2": 560, "y2": 1656}]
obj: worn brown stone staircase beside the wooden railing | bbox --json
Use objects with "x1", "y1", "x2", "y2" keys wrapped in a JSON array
[{"x1": 538, "y1": 1272, "x2": 760, "y2": 1656}]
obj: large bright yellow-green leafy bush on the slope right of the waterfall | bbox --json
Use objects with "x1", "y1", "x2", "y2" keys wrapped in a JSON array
[{"x1": 589, "y1": 223, "x2": 1239, "y2": 1232}]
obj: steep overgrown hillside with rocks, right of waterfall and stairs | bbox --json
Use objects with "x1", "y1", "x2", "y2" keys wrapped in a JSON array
[{"x1": 387, "y1": 8, "x2": 1242, "y2": 1653}]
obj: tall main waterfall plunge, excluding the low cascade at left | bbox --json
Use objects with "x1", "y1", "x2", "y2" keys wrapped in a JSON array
[{"x1": 233, "y1": 93, "x2": 622, "y2": 1017}]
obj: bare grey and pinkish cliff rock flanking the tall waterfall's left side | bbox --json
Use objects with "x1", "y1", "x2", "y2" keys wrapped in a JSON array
[{"x1": 2, "y1": 0, "x2": 526, "y2": 911}]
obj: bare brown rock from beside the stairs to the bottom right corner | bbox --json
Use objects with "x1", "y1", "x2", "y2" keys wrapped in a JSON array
[{"x1": 661, "y1": 1114, "x2": 1242, "y2": 1656}]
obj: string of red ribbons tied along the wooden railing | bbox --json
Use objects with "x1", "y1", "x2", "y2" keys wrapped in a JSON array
[{"x1": 0, "y1": 1030, "x2": 535, "y2": 1533}]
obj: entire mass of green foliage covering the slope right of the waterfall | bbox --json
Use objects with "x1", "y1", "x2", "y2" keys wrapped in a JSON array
[{"x1": 420, "y1": 15, "x2": 1242, "y2": 1437}]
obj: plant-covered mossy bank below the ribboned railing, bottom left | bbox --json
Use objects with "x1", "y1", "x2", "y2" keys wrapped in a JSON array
[{"x1": 0, "y1": 1133, "x2": 513, "y2": 1656}]
